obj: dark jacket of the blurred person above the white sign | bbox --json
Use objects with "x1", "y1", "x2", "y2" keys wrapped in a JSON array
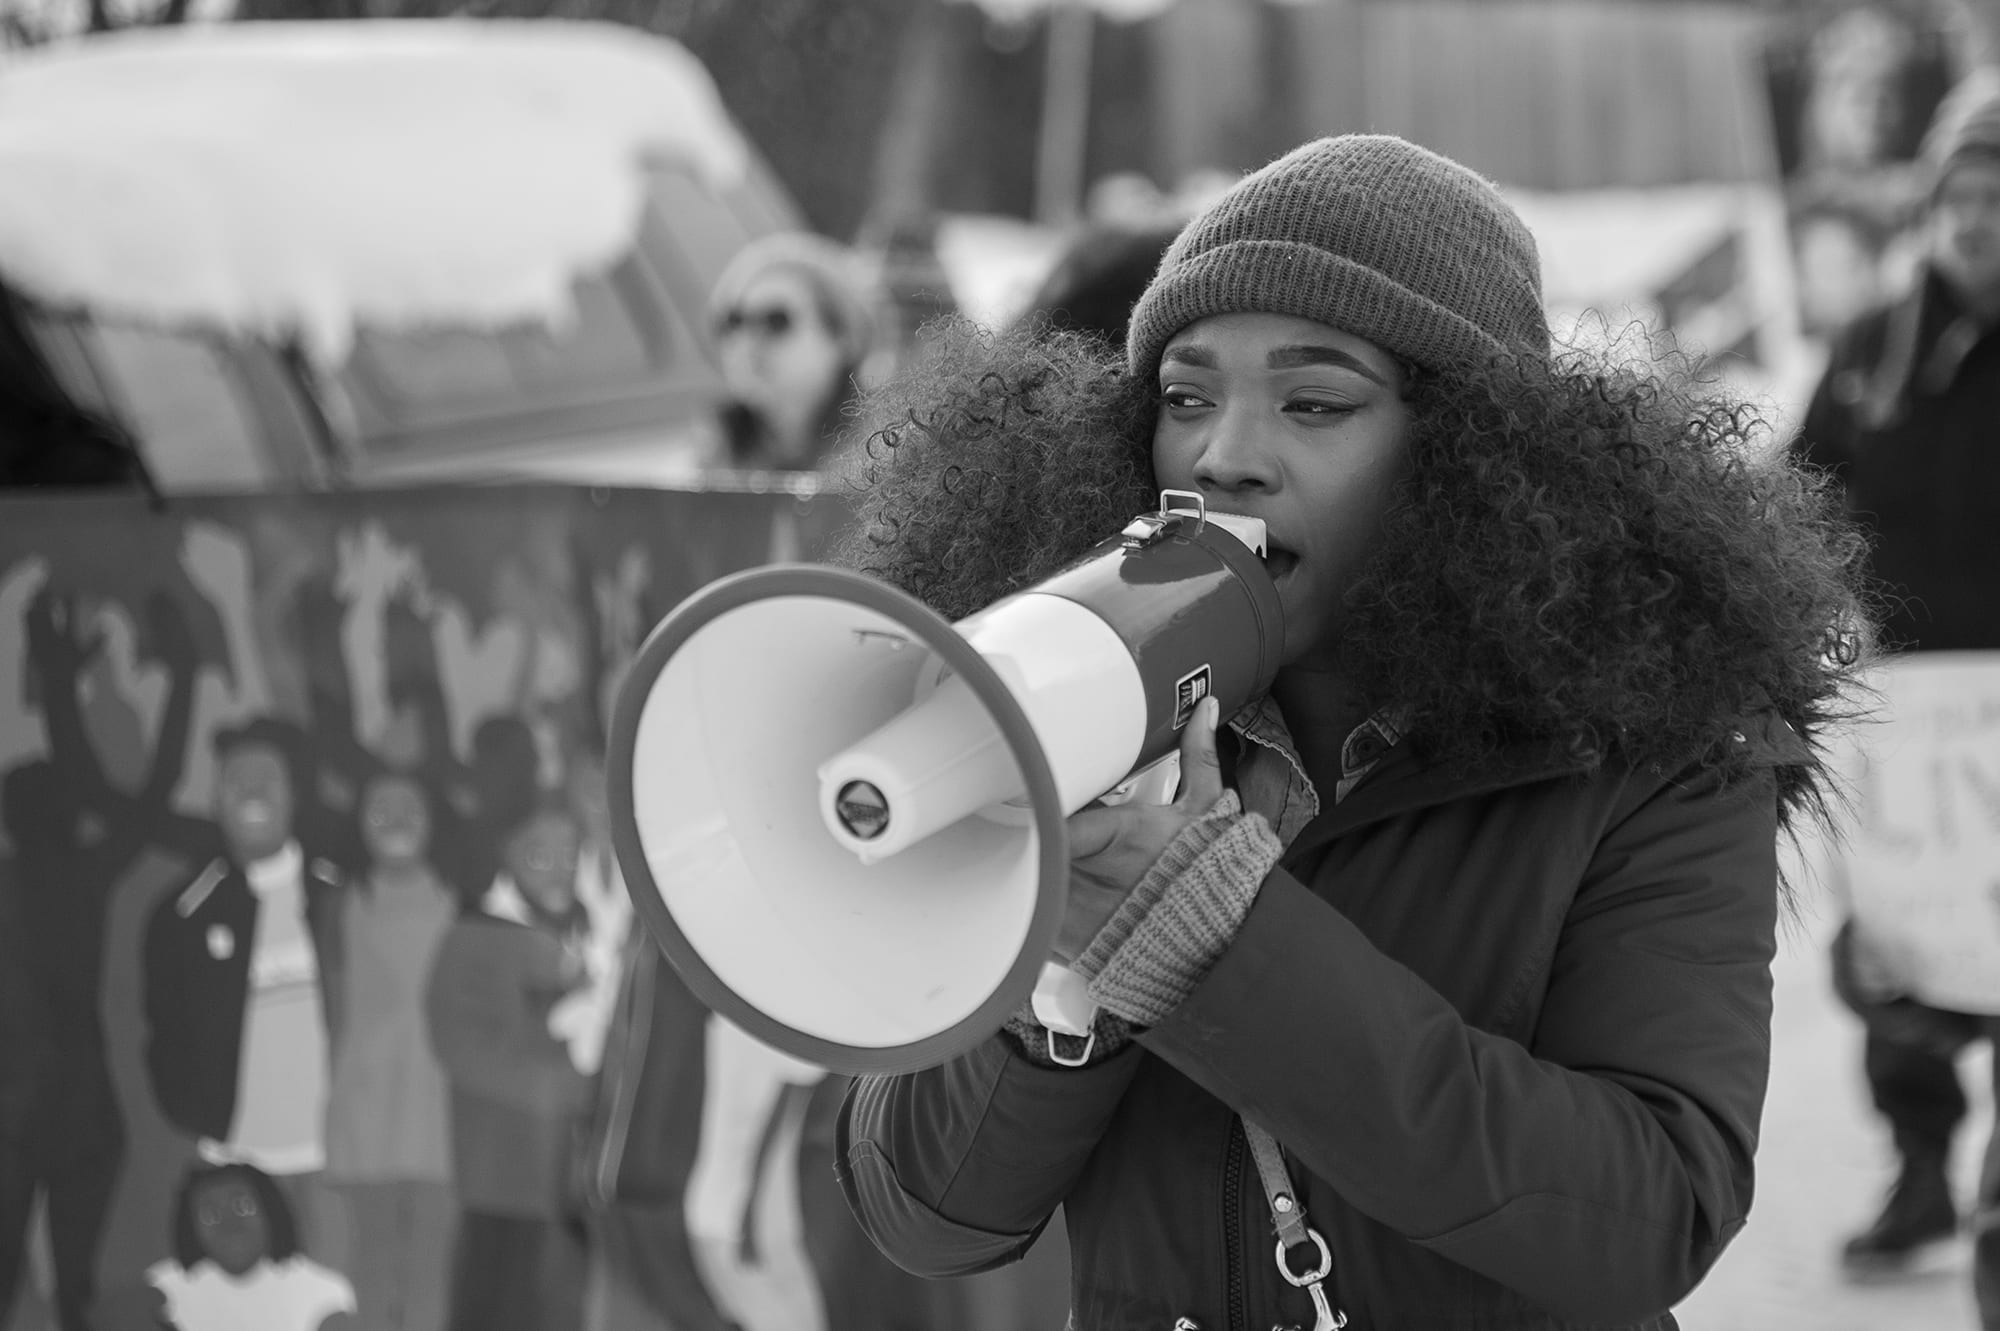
[{"x1": 1792, "y1": 263, "x2": 2000, "y2": 652}]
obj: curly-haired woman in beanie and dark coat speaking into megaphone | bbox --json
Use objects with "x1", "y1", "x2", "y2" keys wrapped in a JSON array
[{"x1": 842, "y1": 136, "x2": 1858, "y2": 1331}]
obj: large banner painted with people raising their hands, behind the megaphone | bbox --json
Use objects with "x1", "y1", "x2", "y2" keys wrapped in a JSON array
[{"x1": 0, "y1": 486, "x2": 1064, "y2": 1331}]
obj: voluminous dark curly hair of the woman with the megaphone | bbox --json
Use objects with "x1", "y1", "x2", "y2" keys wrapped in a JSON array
[{"x1": 840, "y1": 315, "x2": 1868, "y2": 825}]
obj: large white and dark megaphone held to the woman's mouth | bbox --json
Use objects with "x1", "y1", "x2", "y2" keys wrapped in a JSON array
[{"x1": 606, "y1": 490, "x2": 1284, "y2": 1073}]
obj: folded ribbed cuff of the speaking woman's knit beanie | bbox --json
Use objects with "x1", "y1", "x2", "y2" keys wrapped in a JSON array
[{"x1": 1126, "y1": 240, "x2": 1546, "y2": 376}]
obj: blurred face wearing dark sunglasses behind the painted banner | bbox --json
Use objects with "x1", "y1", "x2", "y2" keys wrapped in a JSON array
[{"x1": 716, "y1": 268, "x2": 846, "y2": 451}]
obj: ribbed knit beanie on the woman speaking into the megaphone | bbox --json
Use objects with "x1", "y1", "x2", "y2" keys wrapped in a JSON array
[{"x1": 1126, "y1": 134, "x2": 1548, "y2": 378}]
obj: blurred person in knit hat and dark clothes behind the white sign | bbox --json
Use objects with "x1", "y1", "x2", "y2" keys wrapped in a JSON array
[{"x1": 1792, "y1": 70, "x2": 2000, "y2": 1287}]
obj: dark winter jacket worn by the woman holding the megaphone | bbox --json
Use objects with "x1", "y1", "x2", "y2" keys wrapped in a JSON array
[{"x1": 840, "y1": 723, "x2": 1804, "y2": 1331}]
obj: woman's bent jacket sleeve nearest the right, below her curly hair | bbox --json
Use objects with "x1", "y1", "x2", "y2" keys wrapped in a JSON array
[{"x1": 1140, "y1": 763, "x2": 1776, "y2": 1325}]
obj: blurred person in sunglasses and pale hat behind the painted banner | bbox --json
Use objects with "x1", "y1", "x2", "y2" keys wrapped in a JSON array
[{"x1": 708, "y1": 232, "x2": 882, "y2": 472}]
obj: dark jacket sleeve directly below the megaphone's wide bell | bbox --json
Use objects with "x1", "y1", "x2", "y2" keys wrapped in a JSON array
[{"x1": 834, "y1": 1019, "x2": 1138, "y2": 1277}]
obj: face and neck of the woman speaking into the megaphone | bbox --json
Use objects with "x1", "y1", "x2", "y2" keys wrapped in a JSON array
[{"x1": 1152, "y1": 314, "x2": 1410, "y2": 666}]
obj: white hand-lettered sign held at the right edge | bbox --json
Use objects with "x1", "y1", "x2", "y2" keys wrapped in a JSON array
[{"x1": 1836, "y1": 652, "x2": 2000, "y2": 1013}]
